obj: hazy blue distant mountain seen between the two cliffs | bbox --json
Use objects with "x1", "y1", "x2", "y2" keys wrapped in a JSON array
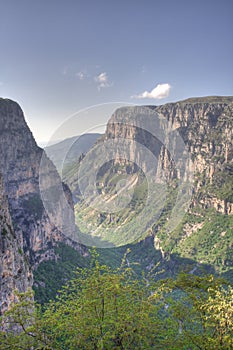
[{"x1": 45, "y1": 133, "x2": 101, "y2": 174}]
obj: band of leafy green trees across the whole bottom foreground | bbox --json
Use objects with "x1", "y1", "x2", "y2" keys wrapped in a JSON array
[{"x1": 0, "y1": 256, "x2": 233, "y2": 350}]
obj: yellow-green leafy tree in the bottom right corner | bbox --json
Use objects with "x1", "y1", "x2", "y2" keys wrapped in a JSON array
[{"x1": 160, "y1": 273, "x2": 233, "y2": 350}]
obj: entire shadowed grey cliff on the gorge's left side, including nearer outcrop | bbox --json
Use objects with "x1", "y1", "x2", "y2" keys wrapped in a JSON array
[{"x1": 0, "y1": 99, "x2": 82, "y2": 312}]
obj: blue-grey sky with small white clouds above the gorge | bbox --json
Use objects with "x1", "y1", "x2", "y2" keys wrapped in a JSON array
[{"x1": 0, "y1": 0, "x2": 233, "y2": 143}]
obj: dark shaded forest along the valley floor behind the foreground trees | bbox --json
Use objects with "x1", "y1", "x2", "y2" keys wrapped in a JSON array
[{"x1": 33, "y1": 237, "x2": 215, "y2": 305}]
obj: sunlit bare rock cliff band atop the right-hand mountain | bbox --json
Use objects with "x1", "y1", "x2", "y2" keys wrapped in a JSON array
[{"x1": 105, "y1": 97, "x2": 233, "y2": 214}]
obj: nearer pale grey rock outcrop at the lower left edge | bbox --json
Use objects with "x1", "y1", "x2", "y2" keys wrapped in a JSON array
[{"x1": 0, "y1": 177, "x2": 32, "y2": 315}]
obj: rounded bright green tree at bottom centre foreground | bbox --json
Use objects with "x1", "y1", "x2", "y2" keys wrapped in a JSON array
[{"x1": 40, "y1": 263, "x2": 171, "y2": 350}]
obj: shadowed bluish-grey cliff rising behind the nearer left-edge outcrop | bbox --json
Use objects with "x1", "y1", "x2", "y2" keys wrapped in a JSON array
[{"x1": 0, "y1": 99, "x2": 75, "y2": 254}]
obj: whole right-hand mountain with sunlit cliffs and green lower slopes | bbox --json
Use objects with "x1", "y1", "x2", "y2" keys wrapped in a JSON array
[{"x1": 65, "y1": 96, "x2": 233, "y2": 273}]
